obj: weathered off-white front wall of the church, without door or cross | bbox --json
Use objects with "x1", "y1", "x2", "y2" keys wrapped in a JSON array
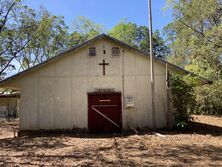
[{"x1": 19, "y1": 40, "x2": 166, "y2": 130}]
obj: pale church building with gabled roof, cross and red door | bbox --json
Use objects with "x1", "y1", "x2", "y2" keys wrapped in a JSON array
[{"x1": 0, "y1": 34, "x2": 209, "y2": 132}]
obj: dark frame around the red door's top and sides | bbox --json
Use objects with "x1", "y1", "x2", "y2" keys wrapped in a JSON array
[{"x1": 87, "y1": 92, "x2": 123, "y2": 131}]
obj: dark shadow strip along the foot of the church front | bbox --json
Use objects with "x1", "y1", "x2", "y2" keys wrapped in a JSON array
[{"x1": 11, "y1": 119, "x2": 222, "y2": 138}]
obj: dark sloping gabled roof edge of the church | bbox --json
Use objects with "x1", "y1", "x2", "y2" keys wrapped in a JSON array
[{"x1": 0, "y1": 34, "x2": 212, "y2": 85}]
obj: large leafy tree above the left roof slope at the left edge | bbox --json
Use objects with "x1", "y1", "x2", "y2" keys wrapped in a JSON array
[{"x1": 0, "y1": 0, "x2": 68, "y2": 74}]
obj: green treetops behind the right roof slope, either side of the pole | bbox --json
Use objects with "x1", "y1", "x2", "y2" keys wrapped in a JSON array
[{"x1": 109, "y1": 19, "x2": 169, "y2": 59}]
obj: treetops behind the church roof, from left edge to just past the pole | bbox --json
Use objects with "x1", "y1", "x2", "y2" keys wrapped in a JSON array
[{"x1": 0, "y1": 0, "x2": 169, "y2": 79}]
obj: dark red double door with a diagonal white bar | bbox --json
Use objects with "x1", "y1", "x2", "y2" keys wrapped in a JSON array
[{"x1": 88, "y1": 93, "x2": 122, "y2": 133}]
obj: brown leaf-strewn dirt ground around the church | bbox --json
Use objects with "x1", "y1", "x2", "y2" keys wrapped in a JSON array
[{"x1": 0, "y1": 116, "x2": 222, "y2": 166}]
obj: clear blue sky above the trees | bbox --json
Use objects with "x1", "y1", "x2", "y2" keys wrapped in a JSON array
[{"x1": 23, "y1": 0, "x2": 172, "y2": 30}]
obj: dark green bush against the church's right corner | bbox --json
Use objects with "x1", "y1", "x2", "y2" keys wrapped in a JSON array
[{"x1": 170, "y1": 75, "x2": 196, "y2": 128}]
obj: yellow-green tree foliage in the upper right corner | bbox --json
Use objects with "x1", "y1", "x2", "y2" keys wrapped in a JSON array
[{"x1": 165, "y1": 0, "x2": 222, "y2": 73}]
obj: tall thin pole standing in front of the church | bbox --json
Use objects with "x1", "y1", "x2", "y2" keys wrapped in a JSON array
[{"x1": 148, "y1": 0, "x2": 156, "y2": 131}]
